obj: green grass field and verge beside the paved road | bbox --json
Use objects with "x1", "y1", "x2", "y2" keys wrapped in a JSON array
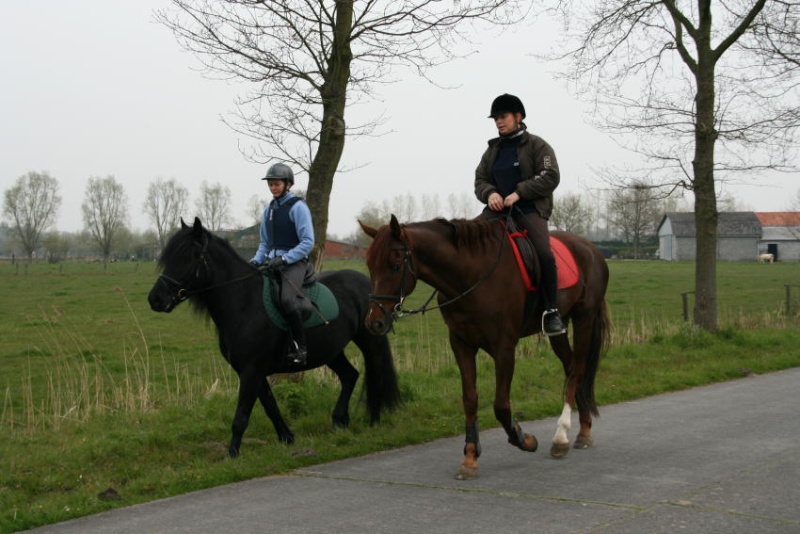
[{"x1": 0, "y1": 261, "x2": 800, "y2": 534}]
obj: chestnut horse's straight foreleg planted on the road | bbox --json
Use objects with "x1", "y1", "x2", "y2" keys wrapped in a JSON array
[{"x1": 450, "y1": 331, "x2": 481, "y2": 480}]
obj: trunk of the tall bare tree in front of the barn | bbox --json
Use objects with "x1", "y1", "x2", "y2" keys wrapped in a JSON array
[{"x1": 692, "y1": 2, "x2": 718, "y2": 332}]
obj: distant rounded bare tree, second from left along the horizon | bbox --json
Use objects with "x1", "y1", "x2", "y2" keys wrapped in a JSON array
[{"x1": 81, "y1": 175, "x2": 128, "y2": 262}]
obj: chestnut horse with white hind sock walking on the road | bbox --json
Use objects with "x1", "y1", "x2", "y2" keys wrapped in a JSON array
[{"x1": 359, "y1": 215, "x2": 610, "y2": 479}]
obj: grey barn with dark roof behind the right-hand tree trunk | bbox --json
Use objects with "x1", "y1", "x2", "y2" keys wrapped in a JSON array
[{"x1": 658, "y1": 211, "x2": 762, "y2": 261}]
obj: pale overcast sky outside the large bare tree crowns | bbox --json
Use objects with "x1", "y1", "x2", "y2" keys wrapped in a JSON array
[{"x1": 0, "y1": 0, "x2": 800, "y2": 236}]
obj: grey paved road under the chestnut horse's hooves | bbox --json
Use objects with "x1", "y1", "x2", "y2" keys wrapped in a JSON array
[{"x1": 21, "y1": 368, "x2": 800, "y2": 534}]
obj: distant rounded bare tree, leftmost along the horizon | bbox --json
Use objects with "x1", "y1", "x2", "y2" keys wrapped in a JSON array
[{"x1": 3, "y1": 172, "x2": 61, "y2": 260}]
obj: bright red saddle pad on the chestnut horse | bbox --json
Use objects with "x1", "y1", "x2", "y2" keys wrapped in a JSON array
[{"x1": 506, "y1": 218, "x2": 578, "y2": 291}]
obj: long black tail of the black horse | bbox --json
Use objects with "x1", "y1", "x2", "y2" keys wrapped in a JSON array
[{"x1": 363, "y1": 334, "x2": 401, "y2": 424}]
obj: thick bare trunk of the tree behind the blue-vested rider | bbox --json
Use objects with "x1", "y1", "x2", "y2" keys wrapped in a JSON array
[{"x1": 307, "y1": 0, "x2": 353, "y2": 270}]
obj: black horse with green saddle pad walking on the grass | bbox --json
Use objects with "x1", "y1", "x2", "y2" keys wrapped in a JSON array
[{"x1": 147, "y1": 218, "x2": 400, "y2": 457}]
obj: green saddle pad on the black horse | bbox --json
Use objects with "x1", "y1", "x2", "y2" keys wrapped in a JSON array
[{"x1": 262, "y1": 265, "x2": 339, "y2": 331}]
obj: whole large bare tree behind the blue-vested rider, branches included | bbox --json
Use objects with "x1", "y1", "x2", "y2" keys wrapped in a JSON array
[{"x1": 157, "y1": 0, "x2": 527, "y2": 264}]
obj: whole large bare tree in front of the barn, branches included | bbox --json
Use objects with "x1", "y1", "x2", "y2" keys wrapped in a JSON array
[{"x1": 557, "y1": 0, "x2": 800, "y2": 331}]
